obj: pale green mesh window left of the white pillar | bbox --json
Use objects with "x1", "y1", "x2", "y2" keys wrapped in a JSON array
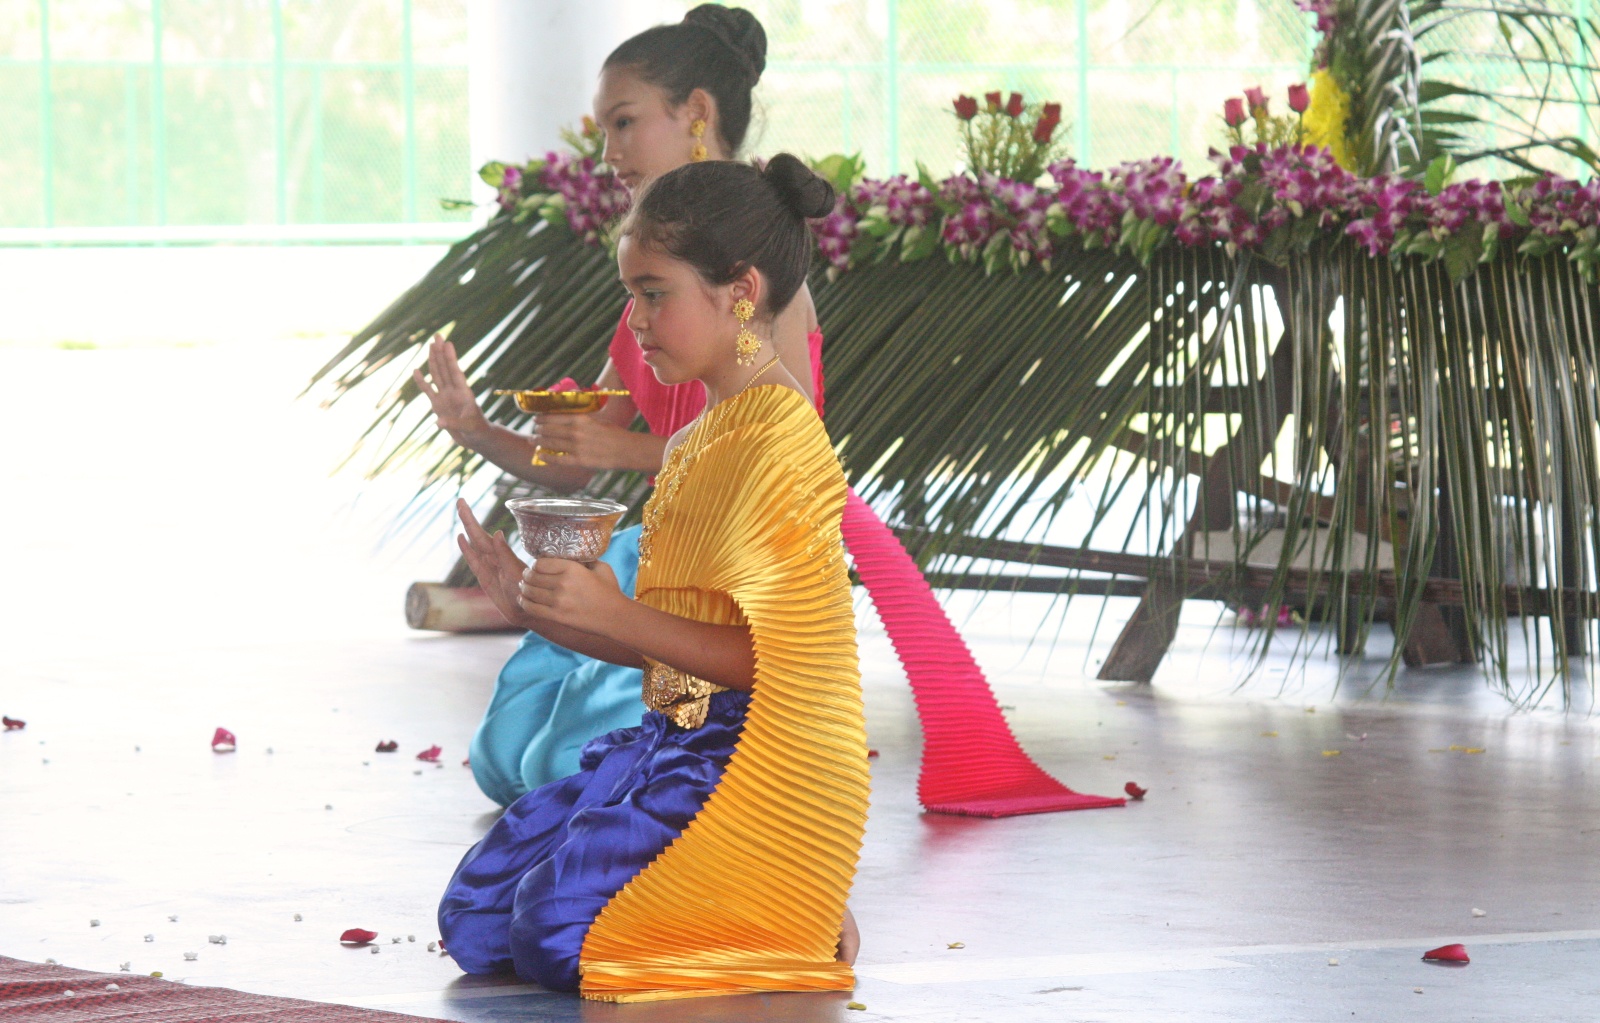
[{"x1": 0, "y1": 0, "x2": 472, "y2": 237}]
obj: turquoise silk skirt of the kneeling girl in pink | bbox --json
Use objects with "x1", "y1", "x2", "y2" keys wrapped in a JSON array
[{"x1": 472, "y1": 525, "x2": 645, "y2": 807}]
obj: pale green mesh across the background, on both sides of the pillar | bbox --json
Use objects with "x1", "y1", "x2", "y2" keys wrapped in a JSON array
[{"x1": 0, "y1": 0, "x2": 1595, "y2": 237}]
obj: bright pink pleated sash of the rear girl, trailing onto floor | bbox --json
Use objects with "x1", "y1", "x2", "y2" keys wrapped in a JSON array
[{"x1": 610, "y1": 312, "x2": 1125, "y2": 816}]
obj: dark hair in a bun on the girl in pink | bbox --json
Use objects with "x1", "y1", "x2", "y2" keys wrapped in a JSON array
[{"x1": 605, "y1": 3, "x2": 766, "y2": 154}]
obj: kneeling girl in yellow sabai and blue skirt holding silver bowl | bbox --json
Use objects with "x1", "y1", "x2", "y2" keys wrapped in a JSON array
[{"x1": 440, "y1": 154, "x2": 867, "y2": 1001}]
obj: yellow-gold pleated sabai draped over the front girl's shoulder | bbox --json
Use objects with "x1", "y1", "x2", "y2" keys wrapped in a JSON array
[{"x1": 581, "y1": 386, "x2": 869, "y2": 1002}]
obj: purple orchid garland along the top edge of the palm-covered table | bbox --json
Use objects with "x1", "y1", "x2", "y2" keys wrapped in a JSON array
[{"x1": 464, "y1": 96, "x2": 1600, "y2": 280}]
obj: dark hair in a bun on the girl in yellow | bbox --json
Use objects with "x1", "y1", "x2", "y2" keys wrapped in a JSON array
[{"x1": 622, "y1": 152, "x2": 834, "y2": 315}]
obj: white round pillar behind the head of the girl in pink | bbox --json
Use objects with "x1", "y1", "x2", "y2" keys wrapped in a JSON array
[{"x1": 467, "y1": 0, "x2": 685, "y2": 199}]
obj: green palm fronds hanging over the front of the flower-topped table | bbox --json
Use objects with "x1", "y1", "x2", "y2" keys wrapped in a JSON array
[{"x1": 315, "y1": 160, "x2": 1600, "y2": 700}]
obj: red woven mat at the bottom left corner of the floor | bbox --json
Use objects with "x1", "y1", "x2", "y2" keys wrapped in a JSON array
[{"x1": 0, "y1": 956, "x2": 443, "y2": 1023}]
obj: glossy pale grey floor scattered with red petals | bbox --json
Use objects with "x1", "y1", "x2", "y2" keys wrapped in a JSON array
[{"x1": 0, "y1": 344, "x2": 1600, "y2": 1023}]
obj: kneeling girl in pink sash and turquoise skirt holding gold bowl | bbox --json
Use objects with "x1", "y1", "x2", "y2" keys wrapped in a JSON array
[{"x1": 416, "y1": 3, "x2": 1123, "y2": 816}]
